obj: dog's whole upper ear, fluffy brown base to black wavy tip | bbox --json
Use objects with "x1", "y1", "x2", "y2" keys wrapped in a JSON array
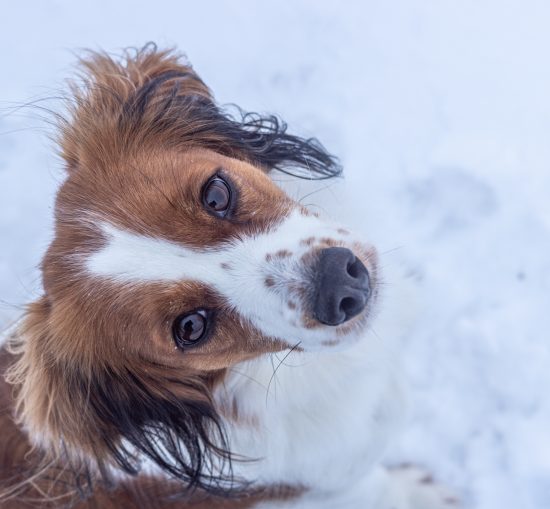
[{"x1": 60, "y1": 44, "x2": 342, "y2": 180}]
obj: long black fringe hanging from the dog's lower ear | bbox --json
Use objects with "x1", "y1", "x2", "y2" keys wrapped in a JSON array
[{"x1": 82, "y1": 370, "x2": 240, "y2": 496}]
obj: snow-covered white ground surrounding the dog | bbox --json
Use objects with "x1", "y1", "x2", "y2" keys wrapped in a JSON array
[{"x1": 0, "y1": 0, "x2": 550, "y2": 509}]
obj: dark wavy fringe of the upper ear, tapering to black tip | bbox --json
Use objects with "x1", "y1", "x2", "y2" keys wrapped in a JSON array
[{"x1": 119, "y1": 70, "x2": 342, "y2": 180}]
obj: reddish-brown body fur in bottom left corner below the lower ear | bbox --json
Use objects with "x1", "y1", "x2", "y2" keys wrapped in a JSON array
[{"x1": 0, "y1": 349, "x2": 300, "y2": 509}]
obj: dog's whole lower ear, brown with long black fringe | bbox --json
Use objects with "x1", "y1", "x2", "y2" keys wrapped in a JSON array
[{"x1": 7, "y1": 298, "x2": 234, "y2": 493}]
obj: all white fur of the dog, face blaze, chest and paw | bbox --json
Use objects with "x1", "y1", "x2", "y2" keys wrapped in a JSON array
[{"x1": 77, "y1": 211, "x2": 450, "y2": 509}]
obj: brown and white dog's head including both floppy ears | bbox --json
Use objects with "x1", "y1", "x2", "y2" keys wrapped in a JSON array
[{"x1": 8, "y1": 48, "x2": 376, "y2": 489}]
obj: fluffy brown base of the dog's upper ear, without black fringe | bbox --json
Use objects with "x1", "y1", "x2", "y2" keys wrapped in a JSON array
[{"x1": 60, "y1": 43, "x2": 211, "y2": 171}]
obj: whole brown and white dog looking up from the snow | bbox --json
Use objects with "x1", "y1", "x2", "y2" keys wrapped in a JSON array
[{"x1": 0, "y1": 45, "x2": 458, "y2": 509}]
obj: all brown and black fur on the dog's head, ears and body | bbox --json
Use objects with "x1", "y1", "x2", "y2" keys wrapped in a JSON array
[{"x1": 0, "y1": 42, "x2": 339, "y2": 509}]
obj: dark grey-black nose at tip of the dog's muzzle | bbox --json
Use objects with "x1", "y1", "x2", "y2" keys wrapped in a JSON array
[{"x1": 313, "y1": 247, "x2": 370, "y2": 325}]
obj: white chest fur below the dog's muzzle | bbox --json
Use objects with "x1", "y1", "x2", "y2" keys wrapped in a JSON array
[{"x1": 216, "y1": 335, "x2": 404, "y2": 488}]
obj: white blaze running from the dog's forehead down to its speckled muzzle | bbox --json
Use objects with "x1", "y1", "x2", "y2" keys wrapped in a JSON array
[{"x1": 84, "y1": 210, "x2": 358, "y2": 346}]
